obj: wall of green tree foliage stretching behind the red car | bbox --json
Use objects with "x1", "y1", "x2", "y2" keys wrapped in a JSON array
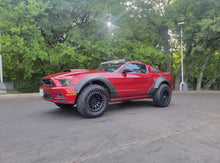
[{"x1": 0, "y1": 0, "x2": 220, "y2": 92}]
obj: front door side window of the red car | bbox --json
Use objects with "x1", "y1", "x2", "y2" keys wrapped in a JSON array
[{"x1": 123, "y1": 63, "x2": 147, "y2": 74}]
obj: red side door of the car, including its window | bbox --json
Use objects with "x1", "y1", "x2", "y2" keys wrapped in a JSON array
[{"x1": 116, "y1": 63, "x2": 153, "y2": 98}]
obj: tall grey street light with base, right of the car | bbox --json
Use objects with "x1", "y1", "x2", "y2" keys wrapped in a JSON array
[{"x1": 178, "y1": 22, "x2": 188, "y2": 91}]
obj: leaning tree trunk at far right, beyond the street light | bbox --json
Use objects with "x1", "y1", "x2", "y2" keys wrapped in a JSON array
[{"x1": 196, "y1": 50, "x2": 215, "y2": 91}]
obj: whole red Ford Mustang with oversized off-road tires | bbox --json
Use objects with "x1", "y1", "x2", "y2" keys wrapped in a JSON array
[{"x1": 40, "y1": 59, "x2": 173, "y2": 118}]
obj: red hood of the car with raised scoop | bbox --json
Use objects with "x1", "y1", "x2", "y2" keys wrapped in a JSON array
[{"x1": 44, "y1": 69, "x2": 105, "y2": 79}]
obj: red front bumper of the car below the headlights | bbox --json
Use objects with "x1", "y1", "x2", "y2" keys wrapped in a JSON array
[{"x1": 40, "y1": 87, "x2": 77, "y2": 104}]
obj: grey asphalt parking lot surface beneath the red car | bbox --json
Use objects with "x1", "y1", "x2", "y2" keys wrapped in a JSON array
[{"x1": 0, "y1": 92, "x2": 220, "y2": 163}]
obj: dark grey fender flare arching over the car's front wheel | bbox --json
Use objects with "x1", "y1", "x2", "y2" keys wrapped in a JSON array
[{"x1": 74, "y1": 75, "x2": 119, "y2": 99}]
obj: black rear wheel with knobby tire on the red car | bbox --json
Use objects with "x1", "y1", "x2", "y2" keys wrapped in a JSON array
[{"x1": 153, "y1": 84, "x2": 172, "y2": 107}]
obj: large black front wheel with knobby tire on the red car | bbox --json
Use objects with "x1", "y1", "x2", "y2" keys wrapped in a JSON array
[{"x1": 76, "y1": 85, "x2": 109, "y2": 118}]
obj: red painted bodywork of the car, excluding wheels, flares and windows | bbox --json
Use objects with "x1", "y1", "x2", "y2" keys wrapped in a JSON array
[{"x1": 40, "y1": 61, "x2": 173, "y2": 104}]
